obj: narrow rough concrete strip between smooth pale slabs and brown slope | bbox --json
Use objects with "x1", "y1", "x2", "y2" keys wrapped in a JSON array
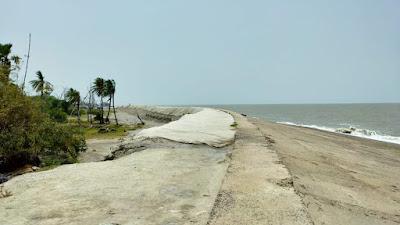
[{"x1": 208, "y1": 114, "x2": 312, "y2": 225}]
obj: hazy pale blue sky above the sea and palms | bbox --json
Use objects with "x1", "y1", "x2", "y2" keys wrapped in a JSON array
[{"x1": 0, "y1": 0, "x2": 400, "y2": 105}]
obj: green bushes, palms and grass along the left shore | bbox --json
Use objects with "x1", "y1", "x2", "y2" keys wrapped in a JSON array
[{"x1": 0, "y1": 44, "x2": 134, "y2": 179}]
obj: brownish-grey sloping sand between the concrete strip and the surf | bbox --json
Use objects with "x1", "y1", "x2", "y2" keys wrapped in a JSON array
[{"x1": 250, "y1": 119, "x2": 400, "y2": 225}]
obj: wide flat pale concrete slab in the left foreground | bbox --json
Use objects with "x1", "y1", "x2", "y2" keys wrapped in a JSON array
[{"x1": 0, "y1": 146, "x2": 227, "y2": 225}]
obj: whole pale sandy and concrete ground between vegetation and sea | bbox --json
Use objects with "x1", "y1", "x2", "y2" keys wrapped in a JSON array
[{"x1": 0, "y1": 107, "x2": 400, "y2": 225}]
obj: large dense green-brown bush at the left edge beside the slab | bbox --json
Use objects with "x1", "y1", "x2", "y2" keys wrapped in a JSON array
[{"x1": 0, "y1": 82, "x2": 85, "y2": 172}]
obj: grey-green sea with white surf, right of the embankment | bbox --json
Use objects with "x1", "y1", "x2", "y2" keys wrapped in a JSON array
[{"x1": 203, "y1": 103, "x2": 400, "y2": 144}]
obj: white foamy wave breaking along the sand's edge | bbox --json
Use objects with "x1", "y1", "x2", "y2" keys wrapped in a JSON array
[{"x1": 277, "y1": 122, "x2": 400, "y2": 144}]
